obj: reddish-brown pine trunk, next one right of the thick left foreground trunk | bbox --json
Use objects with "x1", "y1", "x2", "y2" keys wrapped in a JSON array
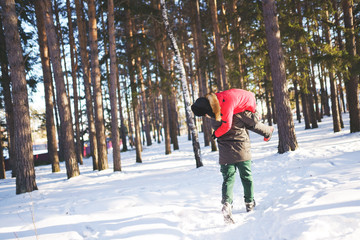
[{"x1": 34, "y1": 1, "x2": 60, "y2": 172}]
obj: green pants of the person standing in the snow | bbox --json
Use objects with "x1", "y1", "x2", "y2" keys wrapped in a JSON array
[{"x1": 221, "y1": 160, "x2": 254, "y2": 204}]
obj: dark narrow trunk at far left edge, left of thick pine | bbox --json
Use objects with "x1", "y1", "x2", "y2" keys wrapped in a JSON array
[{"x1": 0, "y1": 16, "x2": 16, "y2": 177}]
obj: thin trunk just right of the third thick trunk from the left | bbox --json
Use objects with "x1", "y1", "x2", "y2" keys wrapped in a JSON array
[{"x1": 66, "y1": 0, "x2": 83, "y2": 165}]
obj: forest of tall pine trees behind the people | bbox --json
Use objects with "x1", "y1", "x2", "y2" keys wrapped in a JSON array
[{"x1": 0, "y1": 0, "x2": 360, "y2": 194}]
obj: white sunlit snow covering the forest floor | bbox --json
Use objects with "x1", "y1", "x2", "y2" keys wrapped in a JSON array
[{"x1": 0, "y1": 114, "x2": 360, "y2": 240}]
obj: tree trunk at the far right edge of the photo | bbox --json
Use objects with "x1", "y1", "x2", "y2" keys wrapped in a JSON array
[{"x1": 342, "y1": 0, "x2": 360, "y2": 133}]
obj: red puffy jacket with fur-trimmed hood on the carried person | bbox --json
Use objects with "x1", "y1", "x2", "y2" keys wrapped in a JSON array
[{"x1": 206, "y1": 89, "x2": 256, "y2": 137}]
